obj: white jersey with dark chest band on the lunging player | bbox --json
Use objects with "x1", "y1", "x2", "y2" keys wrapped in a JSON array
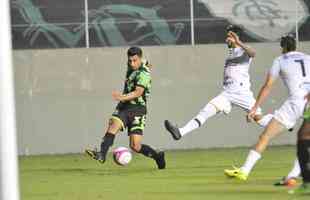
[{"x1": 223, "y1": 47, "x2": 252, "y2": 92}]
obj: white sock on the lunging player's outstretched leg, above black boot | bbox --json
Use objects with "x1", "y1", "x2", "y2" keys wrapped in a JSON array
[{"x1": 179, "y1": 103, "x2": 217, "y2": 136}]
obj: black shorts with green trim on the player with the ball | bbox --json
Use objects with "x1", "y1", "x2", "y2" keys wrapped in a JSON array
[{"x1": 111, "y1": 107, "x2": 146, "y2": 135}]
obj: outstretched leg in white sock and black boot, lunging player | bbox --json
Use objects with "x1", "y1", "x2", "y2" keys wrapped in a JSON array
[{"x1": 165, "y1": 93, "x2": 231, "y2": 140}]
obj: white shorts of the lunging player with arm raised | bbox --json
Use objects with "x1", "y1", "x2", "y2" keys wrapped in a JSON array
[{"x1": 210, "y1": 90, "x2": 262, "y2": 115}]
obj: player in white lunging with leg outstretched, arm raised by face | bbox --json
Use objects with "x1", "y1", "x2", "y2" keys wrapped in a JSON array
[{"x1": 165, "y1": 25, "x2": 272, "y2": 140}]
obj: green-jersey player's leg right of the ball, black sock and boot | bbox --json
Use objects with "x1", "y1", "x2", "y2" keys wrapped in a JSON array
[{"x1": 129, "y1": 133, "x2": 166, "y2": 169}]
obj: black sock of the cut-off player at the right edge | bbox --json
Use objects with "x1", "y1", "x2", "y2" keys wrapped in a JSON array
[{"x1": 297, "y1": 140, "x2": 310, "y2": 183}]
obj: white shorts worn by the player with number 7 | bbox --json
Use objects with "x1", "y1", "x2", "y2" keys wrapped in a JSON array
[{"x1": 274, "y1": 98, "x2": 307, "y2": 129}]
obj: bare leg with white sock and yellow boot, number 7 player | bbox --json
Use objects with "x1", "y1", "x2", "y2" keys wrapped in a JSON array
[{"x1": 224, "y1": 119, "x2": 285, "y2": 180}]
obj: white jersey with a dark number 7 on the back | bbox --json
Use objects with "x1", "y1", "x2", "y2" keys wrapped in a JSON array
[{"x1": 269, "y1": 51, "x2": 310, "y2": 98}]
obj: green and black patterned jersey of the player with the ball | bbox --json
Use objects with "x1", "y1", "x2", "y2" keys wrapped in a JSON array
[{"x1": 118, "y1": 63, "x2": 151, "y2": 108}]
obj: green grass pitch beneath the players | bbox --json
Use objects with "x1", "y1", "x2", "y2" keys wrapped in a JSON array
[{"x1": 20, "y1": 146, "x2": 310, "y2": 200}]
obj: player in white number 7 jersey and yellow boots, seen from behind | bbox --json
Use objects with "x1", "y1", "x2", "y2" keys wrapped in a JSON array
[{"x1": 224, "y1": 35, "x2": 310, "y2": 184}]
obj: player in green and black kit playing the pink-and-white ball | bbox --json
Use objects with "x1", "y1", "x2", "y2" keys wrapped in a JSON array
[{"x1": 86, "y1": 47, "x2": 166, "y2": 169}]
